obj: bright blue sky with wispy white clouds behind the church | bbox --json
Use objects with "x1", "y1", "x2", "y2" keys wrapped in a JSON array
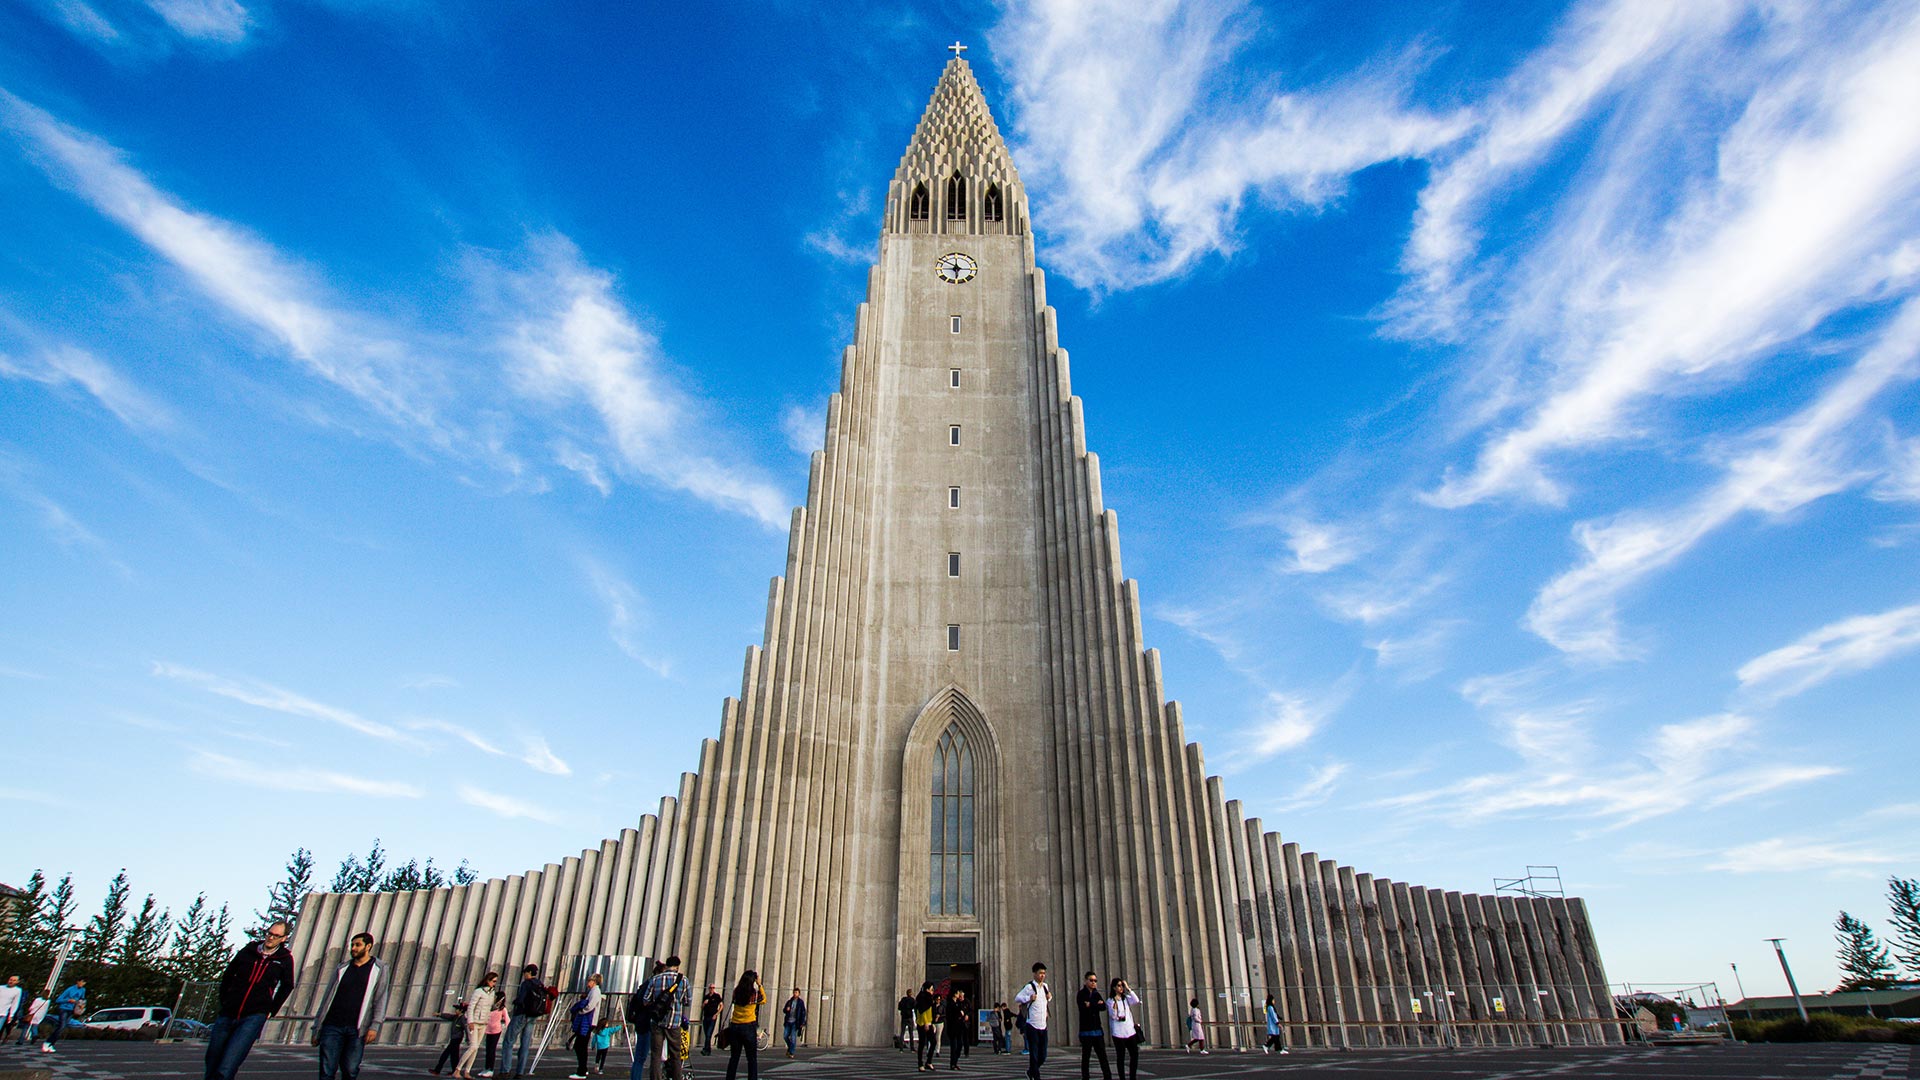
[{"x1": 0, "y1": 0, "x2": 1920, "y2": 994}]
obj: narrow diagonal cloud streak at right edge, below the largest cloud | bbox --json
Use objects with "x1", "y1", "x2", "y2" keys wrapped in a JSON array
[{"x1": 1526, "y1": 290, "x2": 1920, "y2": 659}]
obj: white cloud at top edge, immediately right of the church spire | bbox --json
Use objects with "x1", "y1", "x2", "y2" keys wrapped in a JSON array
[{"x1": 989, "y1": 0, "x2": 1467, "y2": 288}]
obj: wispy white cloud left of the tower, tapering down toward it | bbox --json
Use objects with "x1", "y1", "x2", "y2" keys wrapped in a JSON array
[{"x1": 501, "y1": 236, "x2": 787, "y2": 527}]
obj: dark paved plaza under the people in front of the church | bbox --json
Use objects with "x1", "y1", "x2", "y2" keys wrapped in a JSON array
[{"x1": 0, "y1": 1042, "x2": 1920, "y2": 1080}]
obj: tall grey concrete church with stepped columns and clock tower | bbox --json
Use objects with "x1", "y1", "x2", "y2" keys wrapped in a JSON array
[{"x1": 278, "y1": 58, "x2": 1617, "y2": 1045}]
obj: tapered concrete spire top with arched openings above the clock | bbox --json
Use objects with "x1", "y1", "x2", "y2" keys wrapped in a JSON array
[{"x1": 885, "y1": 56, "x2": 1027, "y2": 234}]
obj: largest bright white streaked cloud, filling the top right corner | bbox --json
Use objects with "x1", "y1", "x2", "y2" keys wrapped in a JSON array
[{"x1": 1432, "y1": 0, "x2": 1920, "y2": 507}]
